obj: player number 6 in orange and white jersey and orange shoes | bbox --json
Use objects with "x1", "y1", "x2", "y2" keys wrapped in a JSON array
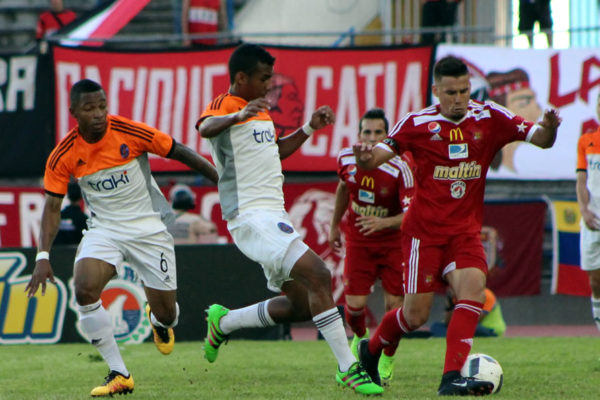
[{"x1": 26, "y1": 79, "x2": 217, "y2": 397}]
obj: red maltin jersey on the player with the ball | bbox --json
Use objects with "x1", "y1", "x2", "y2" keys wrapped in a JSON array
[{"x1": 377, "y1": 100, "x2": 537, "y2": 242}]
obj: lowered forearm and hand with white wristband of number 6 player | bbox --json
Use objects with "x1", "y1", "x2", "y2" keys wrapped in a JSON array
[{"x1": 25, "y1": 194, "x2": 63, "y2": 297}]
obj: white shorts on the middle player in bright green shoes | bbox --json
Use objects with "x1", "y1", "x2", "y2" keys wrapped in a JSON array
[{"x1": 227, "y1": 210, "x2": 308, "y2": 292}]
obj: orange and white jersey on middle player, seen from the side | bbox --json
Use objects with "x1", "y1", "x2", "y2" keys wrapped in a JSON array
[{"x1": 199, "y1": 93, "x2": 284, "y2": 220}]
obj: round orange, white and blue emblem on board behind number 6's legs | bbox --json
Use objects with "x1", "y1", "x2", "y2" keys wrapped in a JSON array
[{"x1": 69, "y1": 264, "x2": 152, "y2": 343}]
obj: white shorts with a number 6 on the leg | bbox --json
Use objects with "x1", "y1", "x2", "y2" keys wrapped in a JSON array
[{"x1": 75, "y1": 228, "x2": 177, "y2": 290}]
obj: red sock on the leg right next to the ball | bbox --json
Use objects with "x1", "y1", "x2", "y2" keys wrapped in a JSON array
[{"x1": 444, "y1": 300, "x2": 483, "y2": 373}]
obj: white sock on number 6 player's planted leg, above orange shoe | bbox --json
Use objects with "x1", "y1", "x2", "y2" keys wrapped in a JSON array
[{"x1": 77, "y1": 300, "x2": 129, "y2": 376}]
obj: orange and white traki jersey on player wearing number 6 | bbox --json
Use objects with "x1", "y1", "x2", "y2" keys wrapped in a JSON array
[{"x1": 44, "y1": 115, "x2": 175, "y2": 236}]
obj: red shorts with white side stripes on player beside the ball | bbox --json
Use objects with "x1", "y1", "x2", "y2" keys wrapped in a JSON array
[{"x1": 401, "y1": 233, "x2": 487, "y2": 293}]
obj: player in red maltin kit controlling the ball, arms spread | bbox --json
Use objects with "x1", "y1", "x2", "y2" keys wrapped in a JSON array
[{"x1": 353, "y1": 56, "x2": 561, "y2": 395}]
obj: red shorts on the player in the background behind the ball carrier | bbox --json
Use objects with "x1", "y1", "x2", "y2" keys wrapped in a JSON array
[{"x1": 344, "y1": 245, "x2": 404, "y2": 296}]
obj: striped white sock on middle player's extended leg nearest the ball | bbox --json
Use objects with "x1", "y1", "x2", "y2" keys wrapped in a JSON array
[{"x1": 313, "y1": 307, "x2": 356, "y2": 372}]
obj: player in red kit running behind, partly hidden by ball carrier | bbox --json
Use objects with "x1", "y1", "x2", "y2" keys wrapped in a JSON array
[{"x1": 329, "y1": 108, "x2": 414, "y2": 385}]
